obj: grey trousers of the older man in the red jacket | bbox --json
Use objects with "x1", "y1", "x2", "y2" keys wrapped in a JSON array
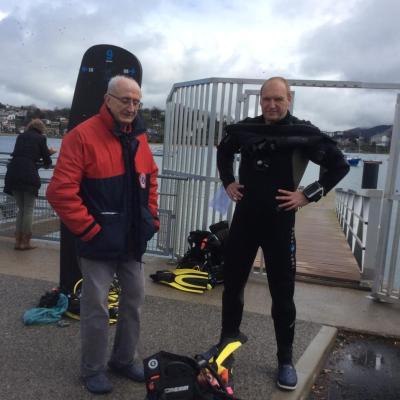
[{"x1": 79, "y1": 258, "x2": 144, "y2": 377}]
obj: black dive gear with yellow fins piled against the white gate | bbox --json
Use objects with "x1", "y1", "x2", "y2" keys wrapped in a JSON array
[{"x1": 150, "y1": 221, "x2": 229, "y2": 294}]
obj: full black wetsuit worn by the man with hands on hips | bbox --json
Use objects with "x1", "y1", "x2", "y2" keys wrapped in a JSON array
[{"x1": 217, "y1": 113, "x2": 349, "y2": 362}]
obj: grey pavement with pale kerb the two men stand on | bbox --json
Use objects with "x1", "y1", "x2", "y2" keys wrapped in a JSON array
[{"x1": 0, "y1": 238, "x2": 400, "y2": 400}]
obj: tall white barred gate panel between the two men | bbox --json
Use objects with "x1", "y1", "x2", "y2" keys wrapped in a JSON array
[{"x1": 160, "y1": 78, "x2": 263, "y2": 255}]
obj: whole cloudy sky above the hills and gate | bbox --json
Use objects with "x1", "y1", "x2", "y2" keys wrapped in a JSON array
[{"x1": 0, "y1": 0, "x2": 400, "y2": 130}]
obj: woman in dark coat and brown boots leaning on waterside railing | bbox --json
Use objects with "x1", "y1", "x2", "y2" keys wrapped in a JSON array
[{"x1": 4, "y1": 118, "x2": 56, "y2": 250}]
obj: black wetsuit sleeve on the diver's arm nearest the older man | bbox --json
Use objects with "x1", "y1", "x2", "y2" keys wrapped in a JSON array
[{"x1": 217, "y1": 130, "x2": 239, "y2": 188}]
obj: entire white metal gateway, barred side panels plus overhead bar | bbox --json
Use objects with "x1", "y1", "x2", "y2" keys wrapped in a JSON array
[{"x1": 160, "y1": 78, "x2": 400, "y2": 299}]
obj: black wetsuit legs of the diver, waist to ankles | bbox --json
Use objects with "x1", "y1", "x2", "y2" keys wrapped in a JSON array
[{"x1": 222, "y1": 198, "x2": 296, "y2": 362}]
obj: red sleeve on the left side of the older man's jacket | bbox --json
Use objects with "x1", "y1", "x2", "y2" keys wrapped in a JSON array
[{"x1": 46, "y1": 130, "x2": 101, "y2": 241}]
